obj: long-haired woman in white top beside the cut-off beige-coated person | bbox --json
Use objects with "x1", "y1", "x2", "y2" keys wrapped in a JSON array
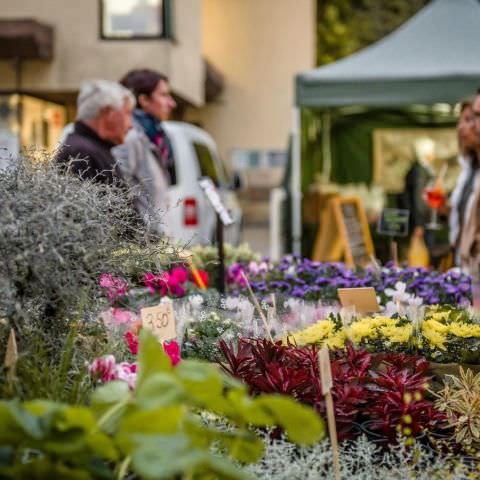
[{"x1": 449, "y1": 97, "x2": 480, "y2": 266}]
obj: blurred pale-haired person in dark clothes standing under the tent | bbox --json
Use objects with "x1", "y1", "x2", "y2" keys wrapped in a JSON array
[{"x1": 403, "y1": 137, "x2": 435, "y2": 244}]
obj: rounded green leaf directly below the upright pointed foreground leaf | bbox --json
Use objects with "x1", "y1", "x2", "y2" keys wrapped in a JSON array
[{"x1": 136, "y1": 373, "x2": 187, "y2": 409}]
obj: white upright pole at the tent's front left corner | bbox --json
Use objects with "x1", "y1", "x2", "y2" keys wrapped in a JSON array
[{"x1": 291, "y1": 107, "x2": 302, "y2": 255}]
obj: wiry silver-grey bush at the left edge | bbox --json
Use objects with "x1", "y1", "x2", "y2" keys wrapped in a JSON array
[{"x1": 0, "y1": 158, "x2": 148, "y2": 329}]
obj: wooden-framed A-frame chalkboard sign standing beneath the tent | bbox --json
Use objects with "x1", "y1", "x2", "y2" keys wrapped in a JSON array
[{"x1": 333, "y1": 197, "x2": 375, "y2": 267}]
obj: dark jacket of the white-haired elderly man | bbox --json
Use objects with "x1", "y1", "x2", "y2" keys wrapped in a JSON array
[{"x1": 56, "y1": 122, "x2": 117, "y2": 183}]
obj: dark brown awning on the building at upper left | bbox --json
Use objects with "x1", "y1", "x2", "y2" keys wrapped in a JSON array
[{"x1": 0, "y1": 19, "x2": 53, "y2": 60}]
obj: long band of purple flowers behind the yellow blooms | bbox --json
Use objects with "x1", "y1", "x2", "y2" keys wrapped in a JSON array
[{"x1": 227, "y1": 256, "x2": 471, "y2": 305}]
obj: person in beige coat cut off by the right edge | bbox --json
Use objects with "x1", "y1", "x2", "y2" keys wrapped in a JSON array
[{"x1": 457, "y1": 90, "x2": 480, "y2": 272}]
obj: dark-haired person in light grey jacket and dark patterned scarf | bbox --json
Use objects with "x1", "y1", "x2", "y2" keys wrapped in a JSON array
[{"x1": 113, "y1": 69, "x2": 176, "y2": 235}]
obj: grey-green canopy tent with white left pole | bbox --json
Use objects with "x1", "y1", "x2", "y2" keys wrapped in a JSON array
[{"x1": 290, "y1": 0, "x2": 480, "y2": 253}]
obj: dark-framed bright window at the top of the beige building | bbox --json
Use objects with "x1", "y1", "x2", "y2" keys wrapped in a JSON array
[{"x1": 100, "y1": 0, "x2": 170, "y2": 40}]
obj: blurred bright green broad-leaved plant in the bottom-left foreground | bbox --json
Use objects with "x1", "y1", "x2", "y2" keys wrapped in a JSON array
[{"x1": 0, "y1": 332, "x2": 324, "y2": 479}]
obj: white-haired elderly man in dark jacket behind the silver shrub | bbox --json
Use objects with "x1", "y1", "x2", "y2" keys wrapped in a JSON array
[{"x1": 56, "y1": 80, "x2": 135, "y2": 183}]
